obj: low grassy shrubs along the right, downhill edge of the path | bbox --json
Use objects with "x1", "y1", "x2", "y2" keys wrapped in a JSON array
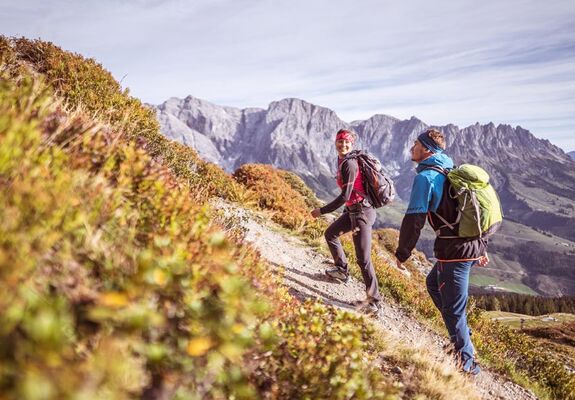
[{"x1": 243, "y1": 163, "x2": 575, "y2": 399}]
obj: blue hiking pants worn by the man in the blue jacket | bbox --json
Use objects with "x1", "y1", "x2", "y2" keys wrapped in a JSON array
[{"x1": 426, "y1": 261, "x2": 476, "y2": 372}]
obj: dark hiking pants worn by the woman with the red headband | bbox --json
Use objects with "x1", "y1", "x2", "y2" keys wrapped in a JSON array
[{"x1": 325, "y1": 204, "x2": 381, "y2": 302}]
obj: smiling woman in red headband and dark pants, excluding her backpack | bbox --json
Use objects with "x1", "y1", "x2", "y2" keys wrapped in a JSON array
[{"x1": 311, "y1": 129, "x2": 381, "y2": 315}]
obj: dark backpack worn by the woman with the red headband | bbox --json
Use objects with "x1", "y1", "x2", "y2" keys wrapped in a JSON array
[{"x1": 345, "y1": 150, "x2": 396, "y2": 208}]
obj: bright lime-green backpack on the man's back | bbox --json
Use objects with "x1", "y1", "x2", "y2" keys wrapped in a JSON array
[{"x1": 433, "y1": 164, "x2": 503, "y2": 238}]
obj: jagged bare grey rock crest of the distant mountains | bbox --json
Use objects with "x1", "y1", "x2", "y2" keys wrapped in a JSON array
[{"x1": 155, "y1": 96, "x2": 575, "y2": 216}]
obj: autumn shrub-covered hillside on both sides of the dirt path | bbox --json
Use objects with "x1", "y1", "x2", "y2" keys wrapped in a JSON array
[{"x1": 0, "y1": 37, "x2": 575, "y2": 399}]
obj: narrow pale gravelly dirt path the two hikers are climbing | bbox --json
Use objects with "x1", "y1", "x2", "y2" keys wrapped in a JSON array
[{"x1": 216, "y1": 201, "x2": 537, "y2": 400}]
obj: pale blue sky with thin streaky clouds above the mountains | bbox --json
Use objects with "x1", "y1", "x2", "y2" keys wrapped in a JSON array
[{"x1": 0, "y1": 0, "x2": 575, "y2": 151}]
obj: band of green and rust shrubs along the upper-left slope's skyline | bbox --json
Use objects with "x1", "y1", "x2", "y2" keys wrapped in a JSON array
[{"x1": 0, "y1": 36, "x2": 245, "y2": 200}]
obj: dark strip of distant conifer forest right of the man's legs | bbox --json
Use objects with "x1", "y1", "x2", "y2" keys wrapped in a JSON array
[{"x1": 473, "y1": 293, "x2": 575, "y2": 316}]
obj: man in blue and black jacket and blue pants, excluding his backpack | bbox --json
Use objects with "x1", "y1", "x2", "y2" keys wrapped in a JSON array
[{"x1": 395, "y1": 129, "x2": 489, "y2": 375}]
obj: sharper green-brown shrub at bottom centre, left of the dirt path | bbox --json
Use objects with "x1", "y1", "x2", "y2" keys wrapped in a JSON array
[{"x1": 256, "y1": 301, "x2": 397, "y2": 399}]
